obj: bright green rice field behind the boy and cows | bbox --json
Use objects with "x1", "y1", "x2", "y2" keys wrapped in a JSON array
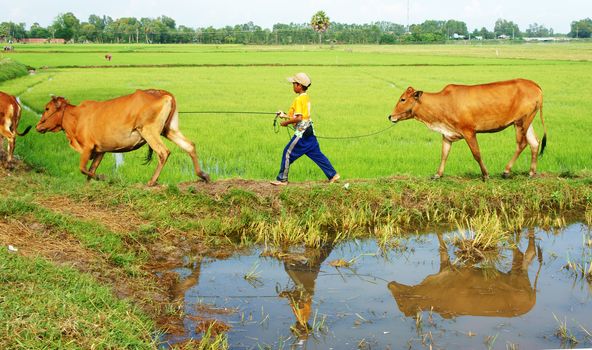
[{"x1": 0, "y1": 43, "x2": 592, "y2": 183}]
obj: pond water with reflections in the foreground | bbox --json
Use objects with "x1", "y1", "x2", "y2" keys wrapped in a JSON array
[{"x1": 163, "y1": 224, "x2": 592, "y2": 349}]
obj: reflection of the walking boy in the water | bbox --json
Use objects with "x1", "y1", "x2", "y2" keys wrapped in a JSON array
[{"x1": 280, "y1": 244, "x2": 333, "y2": 337}]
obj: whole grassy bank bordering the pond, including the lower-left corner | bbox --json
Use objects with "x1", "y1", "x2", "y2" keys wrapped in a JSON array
[{"x1": 0, "y1": 163, "x2": 592, "y2": 348}]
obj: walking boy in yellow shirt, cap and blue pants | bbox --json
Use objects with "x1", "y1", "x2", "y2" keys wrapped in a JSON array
[{"x1": 271, "y1": 73, "x2": 340, "y2": 186}]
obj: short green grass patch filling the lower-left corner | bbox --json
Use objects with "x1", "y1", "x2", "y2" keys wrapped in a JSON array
[{"x1": 0, "y1": 249, "x2": 155, "y2": 349}]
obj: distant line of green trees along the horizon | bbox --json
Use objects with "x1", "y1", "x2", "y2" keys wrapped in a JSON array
[{"x1": 0, "y1": 12, "x2": 592, "y2": 45}]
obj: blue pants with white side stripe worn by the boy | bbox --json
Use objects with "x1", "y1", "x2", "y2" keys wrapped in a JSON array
[{"x1": 277, "y1": 135, "x2": 337, "y2": 181}]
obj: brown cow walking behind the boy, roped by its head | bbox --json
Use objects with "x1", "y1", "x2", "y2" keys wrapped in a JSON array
[{"x1": 388, "y1": 79, "x2": 547, "y2": 179}]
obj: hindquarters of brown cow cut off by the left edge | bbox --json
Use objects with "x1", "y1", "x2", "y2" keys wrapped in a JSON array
[{"x1": 0, "y1": 92, "x2": 31, "y2": 163}]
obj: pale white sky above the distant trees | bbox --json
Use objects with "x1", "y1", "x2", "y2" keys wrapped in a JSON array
[{"x1": 0, "y1": 0, "x2": 592, "y2": 33}]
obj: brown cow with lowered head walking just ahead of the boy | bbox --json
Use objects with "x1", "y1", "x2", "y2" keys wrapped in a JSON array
[{"x1": 37, "y1": 90, "x2": 210, "y2": 186}]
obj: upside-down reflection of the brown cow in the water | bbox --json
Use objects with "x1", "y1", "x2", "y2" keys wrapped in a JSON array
[{"x1": 388, "y1": 233, "x2": 542, "y2": 318}]
